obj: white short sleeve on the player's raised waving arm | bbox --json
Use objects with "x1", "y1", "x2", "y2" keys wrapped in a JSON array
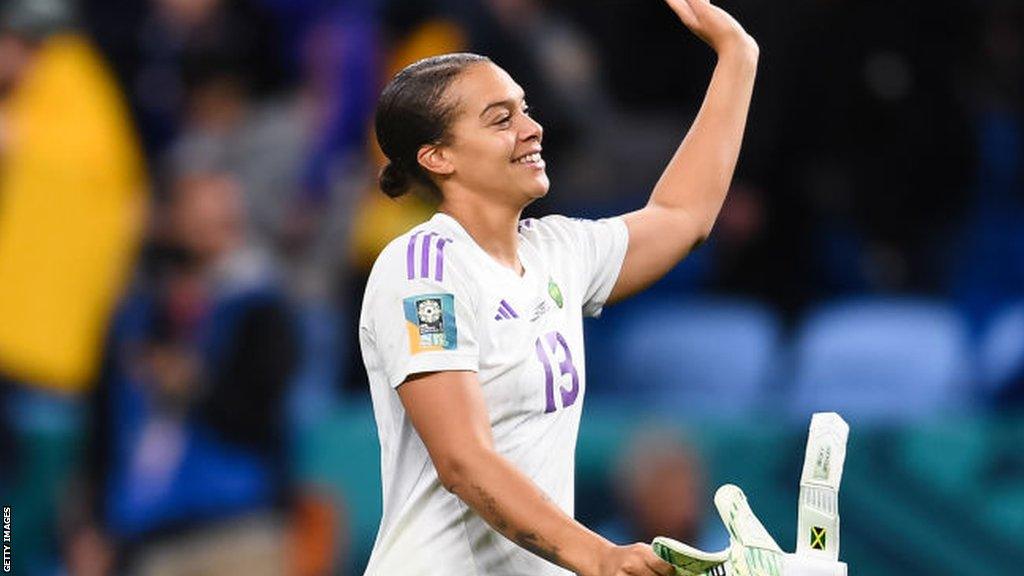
[{"x1": 543, "y1": 216, "x2": 629, "y2": 317}]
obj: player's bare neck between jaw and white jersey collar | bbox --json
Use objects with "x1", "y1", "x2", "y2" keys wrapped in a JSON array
[{"x1": 437, "y1": 189, "x2": 523, "y2": 275}]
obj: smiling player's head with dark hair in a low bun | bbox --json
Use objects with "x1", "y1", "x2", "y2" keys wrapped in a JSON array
[{"x1": 377, "y1": 53, "x2": 550, "y2": 211}]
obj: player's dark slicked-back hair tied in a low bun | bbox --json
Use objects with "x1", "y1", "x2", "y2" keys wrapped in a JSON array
[{"x1": 375, "y1": 53, "x2": 490, "y2": 198}]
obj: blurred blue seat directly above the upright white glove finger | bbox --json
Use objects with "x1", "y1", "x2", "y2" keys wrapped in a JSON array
[{"x1": 794, "y1": 298, "x2": 973, "y2": 421}]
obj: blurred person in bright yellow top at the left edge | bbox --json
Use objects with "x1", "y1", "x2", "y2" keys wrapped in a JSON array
[{"x1": 0, "y1": 0, "x2": 145, "y2": 574}]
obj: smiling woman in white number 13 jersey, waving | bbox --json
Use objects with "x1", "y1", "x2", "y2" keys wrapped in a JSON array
[{"x1": 359, "y1": 0, "x2": 758, "y2": 576}]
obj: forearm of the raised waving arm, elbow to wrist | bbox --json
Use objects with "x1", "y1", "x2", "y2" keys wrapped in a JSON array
[{"x1": 648, "y1": 41, "x2": 758, "y2": 236}]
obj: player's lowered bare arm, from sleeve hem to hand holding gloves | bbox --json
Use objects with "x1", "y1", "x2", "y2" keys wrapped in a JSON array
[{"x1": 398, "y1": 371, "x2": 675, "y2": 576}]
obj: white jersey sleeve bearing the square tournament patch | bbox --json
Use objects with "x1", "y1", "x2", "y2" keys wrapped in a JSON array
[{"x1": 365, "y1": 241, "x2": 479, "y2": 387}]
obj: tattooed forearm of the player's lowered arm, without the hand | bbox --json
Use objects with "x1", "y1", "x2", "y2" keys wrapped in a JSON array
[{"x1": 447, "y1": 450, "x2": 612, "y2": 576}]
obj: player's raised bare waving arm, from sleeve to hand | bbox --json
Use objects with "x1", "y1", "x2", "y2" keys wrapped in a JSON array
[{"x1": 608, "y1": 0, "x2": 759, "y2": 301}]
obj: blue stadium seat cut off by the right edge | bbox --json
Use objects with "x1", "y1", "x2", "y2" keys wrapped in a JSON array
[{"x1": 978, "y1": 300, "x2": 1024, "y2": 398}]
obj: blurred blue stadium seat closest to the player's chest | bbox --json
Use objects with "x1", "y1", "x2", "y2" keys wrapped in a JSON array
[{"x1": 606, "y1": 298, "x2": 781, "y2": 419}]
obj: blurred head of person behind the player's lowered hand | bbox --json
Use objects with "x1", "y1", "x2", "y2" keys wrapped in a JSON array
[{"x1": 597, "y1": 427, "x2": 724, "y2": 550}]
